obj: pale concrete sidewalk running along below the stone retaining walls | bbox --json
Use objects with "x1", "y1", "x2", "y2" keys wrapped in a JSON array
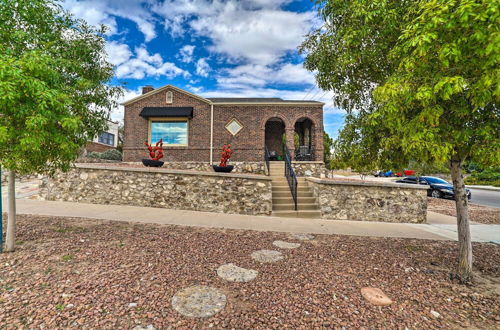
[{"x1": 4, "y1": 199, "x2": 500, "y2": 242}]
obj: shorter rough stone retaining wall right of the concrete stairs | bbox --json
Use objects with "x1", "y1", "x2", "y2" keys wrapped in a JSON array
[{"x1": 307, "y1": 178, "x2": 427, "y2": 223}]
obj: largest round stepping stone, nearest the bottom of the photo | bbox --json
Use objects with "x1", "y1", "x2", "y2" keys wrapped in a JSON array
[{"x1": 172, "y1": 285, "x2": 226, "y2": 317}]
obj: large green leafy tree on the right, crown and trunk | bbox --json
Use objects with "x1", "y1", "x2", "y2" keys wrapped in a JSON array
[{"x1": 303, "y1": 0, "x2": 500, "y2": 282}]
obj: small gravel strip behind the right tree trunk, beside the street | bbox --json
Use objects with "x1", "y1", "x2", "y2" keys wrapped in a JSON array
[{"x1": 427, "y1": 197, "x2": 500, "y2": 225}]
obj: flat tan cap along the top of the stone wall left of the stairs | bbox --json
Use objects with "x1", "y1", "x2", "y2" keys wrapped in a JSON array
[{"x1": 74, "y1": 163, "x2": 272, "y2": 181}]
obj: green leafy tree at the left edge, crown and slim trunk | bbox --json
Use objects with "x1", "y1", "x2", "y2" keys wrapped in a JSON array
[{"x1": 0, "y1": 0, "x2": 121, "y2": 251}]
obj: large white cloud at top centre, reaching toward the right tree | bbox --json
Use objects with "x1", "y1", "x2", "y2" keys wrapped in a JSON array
[{"x1": 152, "y1": 0, "x2": 317, "y2": 65}]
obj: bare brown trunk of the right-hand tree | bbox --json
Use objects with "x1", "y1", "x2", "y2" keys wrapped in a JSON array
[{"x1": 451, "y1": 159, "x2": 472, "y2": 283}]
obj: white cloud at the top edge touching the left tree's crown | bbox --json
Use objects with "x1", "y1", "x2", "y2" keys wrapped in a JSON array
[{"x1": 63, "y1": 0, "x2": 156, "y2": 42}]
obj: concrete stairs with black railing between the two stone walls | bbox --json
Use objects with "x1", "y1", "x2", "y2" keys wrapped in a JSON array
[{"x1": 269, "y1": 162, "x2": 321, "y2": 218}]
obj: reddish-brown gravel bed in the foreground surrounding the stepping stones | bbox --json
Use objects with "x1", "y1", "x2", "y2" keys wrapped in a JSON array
[{"x1": 0, "y1": 216, "x2": 500, "y2": 329}]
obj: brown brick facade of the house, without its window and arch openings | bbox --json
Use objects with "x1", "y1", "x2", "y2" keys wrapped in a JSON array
[{"x1": 123, "y1": 85, "x2": 323, "y2": 162}]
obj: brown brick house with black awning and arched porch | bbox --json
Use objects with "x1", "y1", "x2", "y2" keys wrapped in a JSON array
[{"x1": 123, "y1": 85, "x2": 323, "y2": 163}]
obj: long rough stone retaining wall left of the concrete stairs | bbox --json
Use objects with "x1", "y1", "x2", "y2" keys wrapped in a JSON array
[{"x1": 40, "y1": 164, "x2": 272, "y2": 215}]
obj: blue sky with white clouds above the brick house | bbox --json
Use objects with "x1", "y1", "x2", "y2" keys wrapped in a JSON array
[{"x1": 63, "y1": 0, "x2": 344, "y2": 136}]
